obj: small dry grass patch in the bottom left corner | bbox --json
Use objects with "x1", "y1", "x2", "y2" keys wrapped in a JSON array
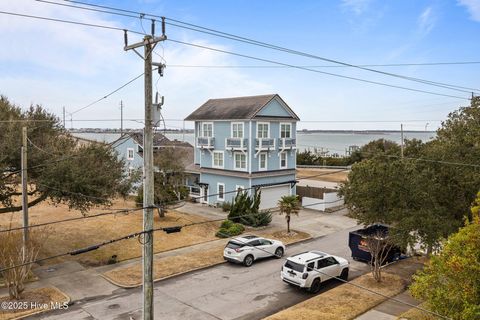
[{"x1": 0, "y1": 287, "x2": 70, "y2": 320}]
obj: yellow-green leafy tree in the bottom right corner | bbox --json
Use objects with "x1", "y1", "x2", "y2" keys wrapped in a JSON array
[{"x1": 410, "y1": 193, "x2": 480, "y2": 320}]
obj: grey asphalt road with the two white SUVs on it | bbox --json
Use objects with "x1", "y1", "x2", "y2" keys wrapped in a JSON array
[{"x1": 30, "y1": 228, "x2": 369, "y2": 320}]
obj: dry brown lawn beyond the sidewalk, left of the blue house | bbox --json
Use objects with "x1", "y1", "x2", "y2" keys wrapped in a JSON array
[{"x1": 0, "y1": 200, "x2": 218, "y2": 266}]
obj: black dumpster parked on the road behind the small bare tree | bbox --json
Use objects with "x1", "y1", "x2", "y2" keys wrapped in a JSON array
[{"x1": 348, "y1": 224, "x2": 402, "y2": 263}]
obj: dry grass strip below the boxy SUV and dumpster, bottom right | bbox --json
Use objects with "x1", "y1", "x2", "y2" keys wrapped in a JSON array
[{"x1": 265, "y1": 258, "x2": 423, "y2": 320}]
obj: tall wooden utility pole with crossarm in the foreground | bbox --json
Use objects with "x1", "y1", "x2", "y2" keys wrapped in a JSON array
[{"x1": 124, "y1": 18, "x2": 167, "y2": 320}]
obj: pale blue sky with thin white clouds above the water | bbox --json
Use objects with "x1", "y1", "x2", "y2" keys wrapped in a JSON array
[{"x1": 0, "y1": 0, "x2": 480, "y2": 130}]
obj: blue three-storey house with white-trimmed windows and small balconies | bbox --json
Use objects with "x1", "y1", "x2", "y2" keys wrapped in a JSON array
[{"x1": 185, "y1": 94, "x2": 299, "y2": 209}]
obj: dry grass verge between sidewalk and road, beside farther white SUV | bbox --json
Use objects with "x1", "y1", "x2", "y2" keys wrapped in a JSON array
[{"x1": 103, "y1": 231, "x2": 310, "y2": 288}]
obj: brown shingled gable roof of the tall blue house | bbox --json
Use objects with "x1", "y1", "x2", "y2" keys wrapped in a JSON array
[{"x1": 185, "y1": 94, "x2": 299, "y2": 121}]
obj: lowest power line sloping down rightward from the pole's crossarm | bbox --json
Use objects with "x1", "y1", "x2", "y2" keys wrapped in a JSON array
[{"x1": 167, "y1": 38, "x2": 470, "y2": 100}]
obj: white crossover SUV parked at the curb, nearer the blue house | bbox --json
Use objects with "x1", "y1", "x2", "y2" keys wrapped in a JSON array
[{"x1": 223, "y1": 235, "x2": 285, "y2": 267}]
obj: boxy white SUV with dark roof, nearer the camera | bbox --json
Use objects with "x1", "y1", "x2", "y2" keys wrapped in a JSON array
[{"x1": 280, "y1": 251, "x2": 349, "y2": 293}]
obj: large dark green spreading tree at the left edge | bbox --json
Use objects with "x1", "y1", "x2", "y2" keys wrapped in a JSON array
[{"x1": 0, "y1": 96, "x2": 130, "y2": 213}]
